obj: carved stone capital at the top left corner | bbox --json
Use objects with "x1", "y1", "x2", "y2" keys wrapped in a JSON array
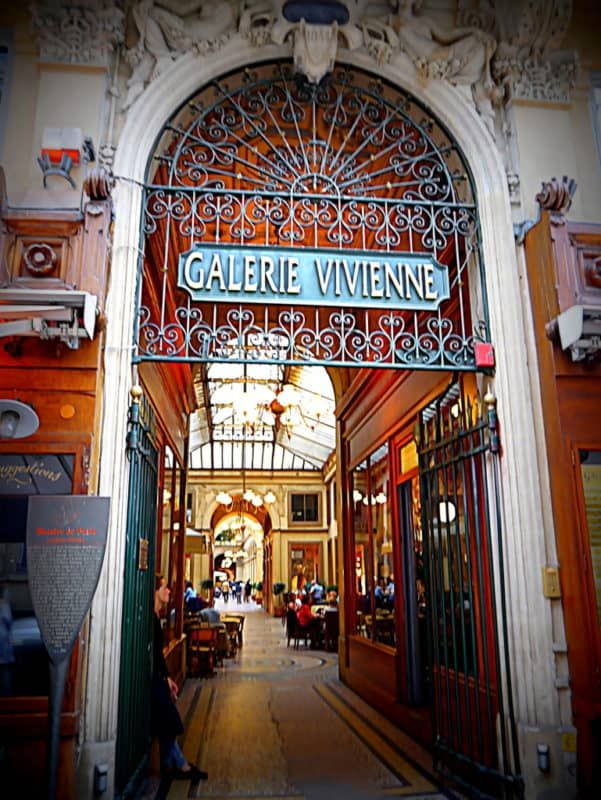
[{"x1": 31, "y1": 0, "x2": 125, "y2": 66}]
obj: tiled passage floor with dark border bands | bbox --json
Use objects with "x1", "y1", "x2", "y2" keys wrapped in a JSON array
[{"x1": 163, "y1": 603, "x2": 444, "y2": 800}]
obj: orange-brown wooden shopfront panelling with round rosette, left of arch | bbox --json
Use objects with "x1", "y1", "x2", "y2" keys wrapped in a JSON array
[{"x1": 0, "y1": 195, "x2": 111, "y2": 800}]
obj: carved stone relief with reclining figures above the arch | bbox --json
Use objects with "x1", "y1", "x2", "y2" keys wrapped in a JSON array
[{"x1": 32, "y1": 0, "x2": 577, "y2": 211}]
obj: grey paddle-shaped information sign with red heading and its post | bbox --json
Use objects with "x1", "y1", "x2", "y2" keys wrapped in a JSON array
[{"x1": 27, "y1": 495, "x2": 110, "y2": 800}]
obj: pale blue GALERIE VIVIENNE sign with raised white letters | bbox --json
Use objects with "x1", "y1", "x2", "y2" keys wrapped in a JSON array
[{"x1": 178, "y1": 244, "x2": 450, "y2": 310}]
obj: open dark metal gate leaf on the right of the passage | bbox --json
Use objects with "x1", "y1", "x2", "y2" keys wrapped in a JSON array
[{"x1": 419, "y1": 384, "x2": 523, "y2": 797}]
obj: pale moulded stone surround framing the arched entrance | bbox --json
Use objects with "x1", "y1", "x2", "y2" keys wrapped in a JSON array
[{"x1": 94, "y1": 36, "x2": 553, "y2": 800}]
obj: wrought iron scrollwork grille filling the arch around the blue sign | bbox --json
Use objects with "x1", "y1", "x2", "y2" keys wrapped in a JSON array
[{"x1": 134, "y1": 63, "x2": 487, "y2": 370}]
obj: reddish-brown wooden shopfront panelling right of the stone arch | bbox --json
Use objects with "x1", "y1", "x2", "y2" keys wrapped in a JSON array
[{"x1": 526, "y1": 212, "x2": 601, "y2": 793}]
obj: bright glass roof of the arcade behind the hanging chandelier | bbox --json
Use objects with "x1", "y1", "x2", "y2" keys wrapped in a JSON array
[{"x1": 190, "y1": 362, "x2": 335, "y2": 470}]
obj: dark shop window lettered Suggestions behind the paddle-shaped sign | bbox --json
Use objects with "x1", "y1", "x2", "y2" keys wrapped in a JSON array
[{"x1": 0, "y1": 453, "x2": 75, "y2": 697}]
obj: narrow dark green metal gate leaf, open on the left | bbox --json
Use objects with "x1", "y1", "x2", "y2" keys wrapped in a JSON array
[{"x1": 115, "y1": 400, "x2": 158, "y2": 798}]
